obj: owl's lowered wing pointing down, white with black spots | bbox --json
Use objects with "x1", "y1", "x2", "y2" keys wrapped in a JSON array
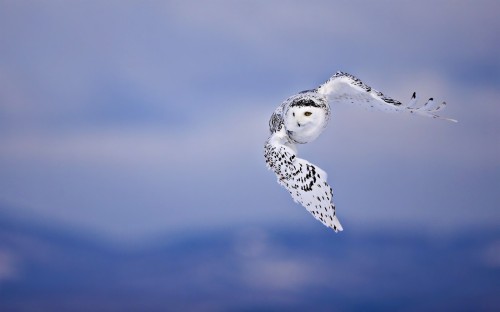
[{"x1": 264, "y1": 129, "x2": 342, "y2": 232}]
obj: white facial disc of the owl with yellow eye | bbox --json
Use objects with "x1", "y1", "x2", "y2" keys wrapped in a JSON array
[{"x1": 284, "y1": 104, "x2": 328, "y2": 143}]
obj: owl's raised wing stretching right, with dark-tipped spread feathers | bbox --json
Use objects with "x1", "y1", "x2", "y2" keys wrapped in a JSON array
[{"x1": 316, "y1": 71, "x2": 456, "y2": 122}]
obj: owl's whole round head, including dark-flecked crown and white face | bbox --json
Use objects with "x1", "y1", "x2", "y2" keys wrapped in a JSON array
[{"x1": 283, "y1": 91, "x2": 330, "y2": 143}]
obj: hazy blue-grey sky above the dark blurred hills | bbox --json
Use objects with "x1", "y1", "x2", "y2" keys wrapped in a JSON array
[{"x1": 0, "y1": 1, "x2": 500, "y2": 243}]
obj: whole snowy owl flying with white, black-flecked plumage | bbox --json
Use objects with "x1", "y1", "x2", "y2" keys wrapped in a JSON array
[{"x1": 264, "y1": 72, "x2": 456, "y2": 232}]
